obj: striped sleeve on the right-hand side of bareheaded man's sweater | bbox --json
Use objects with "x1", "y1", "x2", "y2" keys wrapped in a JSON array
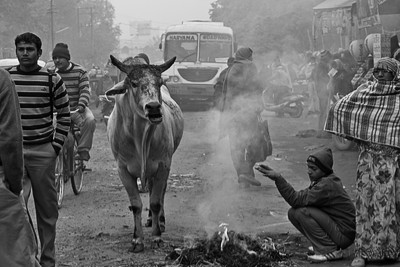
[{"x1": 53, "y1": 74, "x2": 71, "y2": 154}]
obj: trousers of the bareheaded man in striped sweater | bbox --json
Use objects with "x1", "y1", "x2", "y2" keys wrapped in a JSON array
[{"x1": 23, "y1": 143, "x2": 58, "y2": 267}]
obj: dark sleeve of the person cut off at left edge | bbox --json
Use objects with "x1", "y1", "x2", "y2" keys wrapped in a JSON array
[{"x1": 0, "y1": 70, "x2": 24, "y2": 195}]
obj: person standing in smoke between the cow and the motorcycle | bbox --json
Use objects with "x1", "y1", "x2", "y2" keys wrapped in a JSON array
[{"x1": 220, "y1": 47, "x2": 272, "y2": 187}]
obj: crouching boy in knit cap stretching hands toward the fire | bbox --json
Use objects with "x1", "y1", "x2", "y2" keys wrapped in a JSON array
[{"x1": 256, "y1": 148, "x2": 356, "y2": 262}]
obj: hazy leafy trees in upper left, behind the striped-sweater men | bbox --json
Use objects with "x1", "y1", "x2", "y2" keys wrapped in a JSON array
[{"x1": 0, "y1": 0, "x2": 121, "y2": 65}]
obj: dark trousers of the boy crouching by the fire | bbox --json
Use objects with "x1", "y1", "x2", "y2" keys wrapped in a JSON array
[{"x1": 288, "y1": 207, "x2": 353, "y2": 254}]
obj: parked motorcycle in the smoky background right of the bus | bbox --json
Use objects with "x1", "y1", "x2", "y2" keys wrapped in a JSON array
[{"x1": 262, "y1": 89, "x2": 305, "y2": 118}]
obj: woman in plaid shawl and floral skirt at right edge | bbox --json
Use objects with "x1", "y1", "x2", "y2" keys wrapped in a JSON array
[{"x1": 325, "y1": 57, "x2": 400, "y2": 266}]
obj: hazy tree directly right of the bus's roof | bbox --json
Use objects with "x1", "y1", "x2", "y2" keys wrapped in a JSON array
[{"x1": 210, "y1": 0, "x2": 323, "y2": 53}]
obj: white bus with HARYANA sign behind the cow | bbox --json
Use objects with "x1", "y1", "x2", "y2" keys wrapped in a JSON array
[{"x1": 160, "y1": 21, "x2": 237, "y2": 106}]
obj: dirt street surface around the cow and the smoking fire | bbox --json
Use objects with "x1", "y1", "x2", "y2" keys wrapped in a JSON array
[{"x1": 30, "y1": 103, "x2": 390, "y2": 267}]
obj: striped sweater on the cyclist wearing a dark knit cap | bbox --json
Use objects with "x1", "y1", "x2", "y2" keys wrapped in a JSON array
[{"x1": 57, "y1": 62, "x2": 90, "y2": 110}]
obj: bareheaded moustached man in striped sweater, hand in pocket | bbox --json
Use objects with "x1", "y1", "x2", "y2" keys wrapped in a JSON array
[{"x1": 9, "y1": 32, "x2": 71, "y2": 267}]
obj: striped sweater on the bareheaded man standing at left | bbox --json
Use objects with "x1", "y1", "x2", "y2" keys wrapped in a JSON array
[{"x1": 9, "y1": 66, "x2": 71, "y2": 154}]
